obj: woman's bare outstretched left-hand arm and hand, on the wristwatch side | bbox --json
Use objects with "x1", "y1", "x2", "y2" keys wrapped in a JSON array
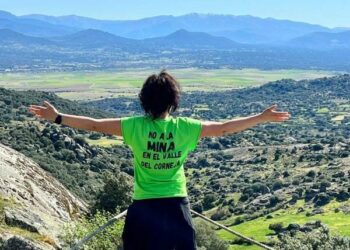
[{"x1": 29, "y1": 101, "x2": 122, "y2": 135}]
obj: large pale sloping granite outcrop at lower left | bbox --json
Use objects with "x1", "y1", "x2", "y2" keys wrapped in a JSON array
[{"x1": 0, "y1": 144, "x2": 86, "y2": 249}]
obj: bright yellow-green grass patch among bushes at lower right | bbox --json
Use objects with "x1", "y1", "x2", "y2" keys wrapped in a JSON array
[{"x1": 217, "y1": 201, "x2": 350, "y2": 250}]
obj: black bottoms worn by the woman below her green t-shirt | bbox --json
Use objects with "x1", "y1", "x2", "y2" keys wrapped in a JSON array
[{"x1": 123, "y1": 197, "x2": 197, "y2": 250}]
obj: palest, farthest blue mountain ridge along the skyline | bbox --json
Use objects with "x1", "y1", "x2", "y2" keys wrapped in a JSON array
[{"x1": 22, "y1": 13, "x2": 330, "y2": 43}]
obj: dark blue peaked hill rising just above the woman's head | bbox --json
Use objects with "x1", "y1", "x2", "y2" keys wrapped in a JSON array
[{"x1": 142, "y1": 29, "x2": 242, "y2": 50}]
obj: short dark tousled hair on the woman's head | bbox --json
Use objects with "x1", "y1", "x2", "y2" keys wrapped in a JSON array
[{"x1": 139, "y1": 70, "x2": 180, "y2": 119}]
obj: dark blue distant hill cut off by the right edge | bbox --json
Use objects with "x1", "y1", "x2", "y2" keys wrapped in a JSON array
[{"x1": 288, "y1": 31, "x2": 350, "y2": 50}]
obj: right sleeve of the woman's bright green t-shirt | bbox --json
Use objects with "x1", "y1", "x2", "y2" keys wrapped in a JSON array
[{"x1": 182, "y1": 117, "x2": 202, "y2": 151}]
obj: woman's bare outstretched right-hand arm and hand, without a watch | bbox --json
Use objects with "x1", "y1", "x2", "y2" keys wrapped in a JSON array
[{"x1": 201, "y1": 105, "x2": 290, "y2": 137}]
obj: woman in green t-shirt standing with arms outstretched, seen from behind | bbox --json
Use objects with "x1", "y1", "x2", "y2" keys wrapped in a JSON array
[{"x1": 30, "y1": 71, "x2": 289, "y2": 250}]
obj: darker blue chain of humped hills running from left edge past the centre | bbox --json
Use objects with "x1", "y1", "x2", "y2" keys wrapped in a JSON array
[{"x1": 0, "y1": 29, "x2": 242, "y2": 51}]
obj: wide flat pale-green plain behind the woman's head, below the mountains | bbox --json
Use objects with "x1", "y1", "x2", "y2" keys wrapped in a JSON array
[{"x1": 0, "y1": 68, "x2": 336, "y2": 100}]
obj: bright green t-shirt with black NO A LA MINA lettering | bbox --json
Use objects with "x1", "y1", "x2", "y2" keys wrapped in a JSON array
[{"x1": 121, "y1": 116, "x2": 202, "y2": 200}]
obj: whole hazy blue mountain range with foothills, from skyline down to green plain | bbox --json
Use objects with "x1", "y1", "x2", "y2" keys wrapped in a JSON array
[{"x1": 0, "y1": 11, "x2": 350, "y2": 71}]
